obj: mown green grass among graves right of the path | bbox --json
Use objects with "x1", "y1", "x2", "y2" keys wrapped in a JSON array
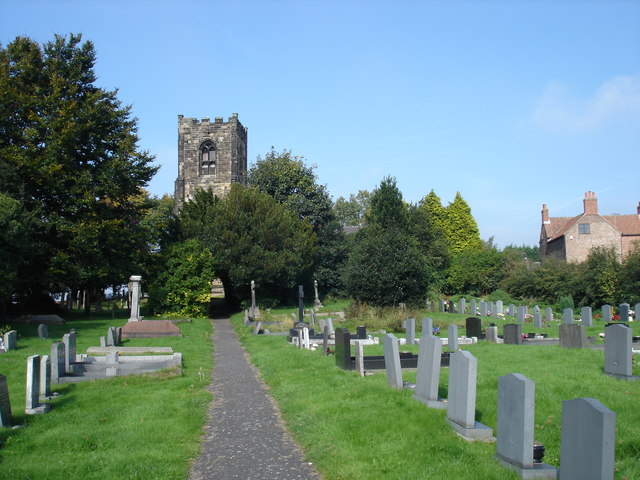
[{"x1": 233, "y1": 306, "x2": 640, "y2": 480}]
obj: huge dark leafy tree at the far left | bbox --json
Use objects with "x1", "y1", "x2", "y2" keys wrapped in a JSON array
[{"x1": 0, "y1": 35, "x2": 156, "y2": 312}]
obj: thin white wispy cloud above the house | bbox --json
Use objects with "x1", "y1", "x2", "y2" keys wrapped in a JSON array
[{"x1": 532, "y1": 74, "x2": 640, "y2": 133}]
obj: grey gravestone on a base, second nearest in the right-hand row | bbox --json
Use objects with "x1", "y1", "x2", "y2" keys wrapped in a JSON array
[{"x1": 496, "y1": 374, "x2": 557, "y2": 479}]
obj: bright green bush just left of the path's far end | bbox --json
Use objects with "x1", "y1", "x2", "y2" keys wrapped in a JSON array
[{"x1": 147, "y1": 239, "x2": 215, "y2": 317}]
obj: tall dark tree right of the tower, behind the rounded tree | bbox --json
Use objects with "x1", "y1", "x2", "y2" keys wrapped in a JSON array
[{"x1": 247, "y1": 148, "x2": 346, "y2": 293}]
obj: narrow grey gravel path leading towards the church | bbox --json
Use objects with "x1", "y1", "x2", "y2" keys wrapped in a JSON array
[{"x1": 189, "y1": 318, "x2": 320, "y2": 480}]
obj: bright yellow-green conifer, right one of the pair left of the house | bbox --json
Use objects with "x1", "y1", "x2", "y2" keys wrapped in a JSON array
[{"x1": 444, "y1": 192, "x2": 483, "y2": 254}]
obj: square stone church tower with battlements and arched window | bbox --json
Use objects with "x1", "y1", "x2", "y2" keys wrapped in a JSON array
[{"x1": 175, "y1": 113, "x2": 247, "y2": 211}]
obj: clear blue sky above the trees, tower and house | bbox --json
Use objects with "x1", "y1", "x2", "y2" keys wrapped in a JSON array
[{"x1": 0, "y1": 0, "x2": 640, "y2": 247}]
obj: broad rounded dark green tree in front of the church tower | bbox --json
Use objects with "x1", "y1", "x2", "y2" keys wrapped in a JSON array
[{"x1": 179, "y1": 184, "x2": 317, "y2": 307}]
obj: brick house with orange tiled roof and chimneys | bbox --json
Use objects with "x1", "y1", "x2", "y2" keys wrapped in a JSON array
[{"x1": 540, "y1": 192, "x2": 640, "y2": 262}]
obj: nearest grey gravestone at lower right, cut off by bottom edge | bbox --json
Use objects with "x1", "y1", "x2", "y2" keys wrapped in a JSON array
[{"x1": 559, "y1": 398, "x2": 616, "y2": 480}]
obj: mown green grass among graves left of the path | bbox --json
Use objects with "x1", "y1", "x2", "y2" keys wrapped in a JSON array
[{"x1": 0, "y1": 313, "x2": 212, "y2": 480}]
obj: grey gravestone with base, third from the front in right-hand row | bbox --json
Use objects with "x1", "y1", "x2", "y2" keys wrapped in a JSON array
[{"x1": 447, "y1": 351, "x2": 493, "y2": 441}]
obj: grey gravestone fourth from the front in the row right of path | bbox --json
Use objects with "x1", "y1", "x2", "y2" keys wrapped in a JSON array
[{"x1": 413, "y1": 334, "x2": 447, "y2": 409}]
